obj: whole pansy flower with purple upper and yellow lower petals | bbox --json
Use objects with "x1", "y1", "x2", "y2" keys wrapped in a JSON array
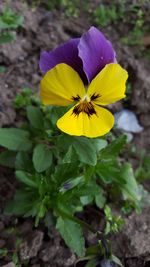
[{"x1": 40, "y1": 27, "x2": 128, "y2": 138}]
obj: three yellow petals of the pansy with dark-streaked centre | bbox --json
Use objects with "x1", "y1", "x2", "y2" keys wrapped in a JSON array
[{"x1": 41, "y1": 63, "x2": 128, "y2": 137}]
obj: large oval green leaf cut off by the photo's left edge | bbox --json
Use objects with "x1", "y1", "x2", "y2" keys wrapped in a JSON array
[{"x1": 0, "y1": 128, "x2": 32, "y2": 151}]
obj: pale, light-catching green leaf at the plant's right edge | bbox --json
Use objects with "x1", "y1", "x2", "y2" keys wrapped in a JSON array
[{"x1": 121, "y1": 163, "x2": 141, "y2": 202}]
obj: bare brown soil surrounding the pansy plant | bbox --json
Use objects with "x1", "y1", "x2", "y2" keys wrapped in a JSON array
[{"x1": 0, "y1": 0, "x2": 150, "y2": 267}]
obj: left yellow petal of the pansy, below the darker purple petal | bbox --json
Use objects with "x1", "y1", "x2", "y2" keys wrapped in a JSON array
[{"x1": 41, "y1": 63, "x2": 85, "y2": 106}]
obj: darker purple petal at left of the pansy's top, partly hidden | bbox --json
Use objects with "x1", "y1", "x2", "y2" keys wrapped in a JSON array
[{"x1": 39, "y1": 38, "x2": 87, "y2": 81}]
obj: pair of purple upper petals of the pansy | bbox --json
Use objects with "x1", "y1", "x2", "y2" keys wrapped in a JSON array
[{"x1": 39, "y1": 26, "x2": 116, "y2": 84}]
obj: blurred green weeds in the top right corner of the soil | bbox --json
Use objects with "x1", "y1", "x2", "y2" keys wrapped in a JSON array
[{"x1": 93, "y1": 0, "x2": 148, "y2": 51}]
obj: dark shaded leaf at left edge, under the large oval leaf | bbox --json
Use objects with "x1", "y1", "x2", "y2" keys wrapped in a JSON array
[{"x1": 0, "y1": 151, "x2": 16, "y2": 168}]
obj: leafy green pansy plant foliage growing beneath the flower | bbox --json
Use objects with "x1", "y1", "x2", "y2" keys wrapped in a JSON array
[{"x1": 0, "y1": 88, "x2": 144, "y2": 266}]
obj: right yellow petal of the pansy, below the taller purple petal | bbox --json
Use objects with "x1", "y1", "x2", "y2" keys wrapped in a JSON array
[{"x1": 87, "y1": 63, "x2": 128, "y2": 105}]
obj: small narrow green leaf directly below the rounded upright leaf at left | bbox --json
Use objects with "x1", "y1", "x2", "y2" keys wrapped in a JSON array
[{"x1": 15, "y1": 171, "x2": 38, "y2": 188}]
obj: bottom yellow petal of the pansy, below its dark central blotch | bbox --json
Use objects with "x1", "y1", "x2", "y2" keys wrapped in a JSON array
[{"x1": 57, "y1": 105, "x2": 114, "y2": 138}]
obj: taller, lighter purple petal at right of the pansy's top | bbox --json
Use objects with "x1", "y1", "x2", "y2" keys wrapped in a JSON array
[{"x1": 78, "y1": 27, "x2": 116, "y2": 82}]
